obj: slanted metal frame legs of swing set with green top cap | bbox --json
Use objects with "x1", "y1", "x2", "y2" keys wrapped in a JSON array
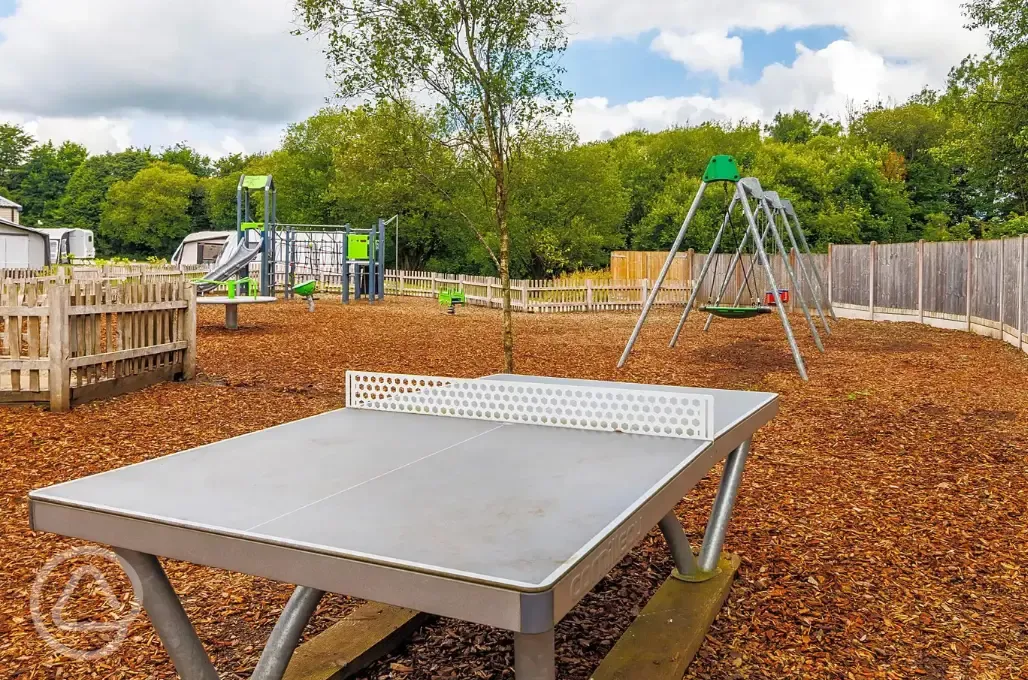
[{"x1": 618, "y1": 156, "x2": 824, "y2": 381}]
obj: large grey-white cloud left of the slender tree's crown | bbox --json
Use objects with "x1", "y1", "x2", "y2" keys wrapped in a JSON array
[{"x1": 0, "y1": 0, "x2": 332, "y2": 153}]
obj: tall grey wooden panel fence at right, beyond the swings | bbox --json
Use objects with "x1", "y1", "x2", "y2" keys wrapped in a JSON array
[{"x1": 829, "y1": 236, "x2": 1028, "y2": 352}]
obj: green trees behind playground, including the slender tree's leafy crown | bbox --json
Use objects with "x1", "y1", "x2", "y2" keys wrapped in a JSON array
[{"x1": 6, "y1": 0, "x2": 1028, "y2": 269}]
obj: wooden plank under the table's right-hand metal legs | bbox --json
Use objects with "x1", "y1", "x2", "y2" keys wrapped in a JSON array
[{"x1": 590, "y1": 554, "x2": 740, "y2": 680}]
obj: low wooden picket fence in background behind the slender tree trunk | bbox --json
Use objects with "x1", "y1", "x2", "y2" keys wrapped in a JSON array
[{"x1": 386, "y1": 270, "x2": 692, "y2": 314}]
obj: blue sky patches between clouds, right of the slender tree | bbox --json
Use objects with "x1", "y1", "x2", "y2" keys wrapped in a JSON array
[{"x1": 559, "y1": 26, "x2": 846, "y2": 105}]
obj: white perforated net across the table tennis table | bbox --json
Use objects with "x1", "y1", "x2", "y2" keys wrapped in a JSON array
[{"x1": 346, "y1": 371, "x2": 713, "y2": 440}]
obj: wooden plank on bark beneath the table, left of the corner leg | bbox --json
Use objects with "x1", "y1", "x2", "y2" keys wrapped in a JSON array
[{"x1": 283, "y1": 602, "x2": 429, "y2": 680}]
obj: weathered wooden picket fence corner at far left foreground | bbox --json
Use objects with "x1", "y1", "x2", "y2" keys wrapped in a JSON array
[{"x1": 0, "y1": 279, "x2": 196, "y2": 410}]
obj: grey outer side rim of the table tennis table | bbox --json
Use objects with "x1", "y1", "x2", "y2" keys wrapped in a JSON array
[{"x1": 30, "y1": 396, "x2": 778, "y2": 632}]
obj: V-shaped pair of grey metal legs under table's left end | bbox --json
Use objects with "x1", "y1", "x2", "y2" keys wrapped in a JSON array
[{"x1": 114, "y1": 548, "x2": 322, "y2": 680}]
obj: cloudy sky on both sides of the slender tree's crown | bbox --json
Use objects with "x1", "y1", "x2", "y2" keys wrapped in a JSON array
[{"x1": 0, "y1": 0, "x2": 985, "y2": 155}]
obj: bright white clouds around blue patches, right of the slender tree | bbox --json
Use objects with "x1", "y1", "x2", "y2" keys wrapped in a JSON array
[{"x1": 568, "y1": 0, "x2": 986, "y2": 140}]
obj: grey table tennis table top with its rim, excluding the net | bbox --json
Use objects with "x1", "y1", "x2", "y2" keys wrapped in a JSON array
[{"x1": 30, "y1": 375, "x2": 777, "y2": 630}]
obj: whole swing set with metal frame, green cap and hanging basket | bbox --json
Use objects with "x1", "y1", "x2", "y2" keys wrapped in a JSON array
[{"x1": 618, "y1": 155, "x2": 835, "y2": 380}]
